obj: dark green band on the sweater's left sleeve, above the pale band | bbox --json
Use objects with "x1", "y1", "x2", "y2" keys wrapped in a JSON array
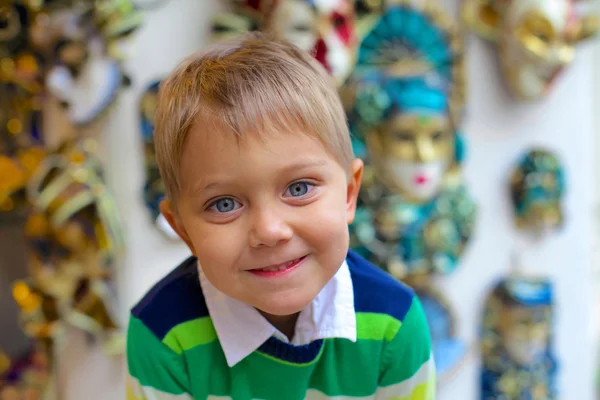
[{"x1": 127, "y1": 317, "x2": 189, "y2": 394}]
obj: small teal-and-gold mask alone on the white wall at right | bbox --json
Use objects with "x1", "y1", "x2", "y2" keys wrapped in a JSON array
[{"x1": 510, "y1": 149, "x2": 565, "y2": 237}]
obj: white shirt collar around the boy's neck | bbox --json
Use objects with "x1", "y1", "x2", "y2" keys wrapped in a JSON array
[{"x1": 198, "y1": 260, "x2": 356, "y2": 367}]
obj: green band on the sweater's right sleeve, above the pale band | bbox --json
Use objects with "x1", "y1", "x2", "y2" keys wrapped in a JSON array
[{"x1": 379, "y1": 296, "x2": 431, "y2": 386}]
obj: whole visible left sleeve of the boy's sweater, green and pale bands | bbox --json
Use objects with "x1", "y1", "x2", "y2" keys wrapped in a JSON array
[{"x1": 126, "y1": 316, "x2": 192, "y2": 400}]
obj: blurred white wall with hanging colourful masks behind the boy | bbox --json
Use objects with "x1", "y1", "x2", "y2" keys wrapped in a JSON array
[{"x1": 0, "y1": 0, "x2": 600, "y2": 400}]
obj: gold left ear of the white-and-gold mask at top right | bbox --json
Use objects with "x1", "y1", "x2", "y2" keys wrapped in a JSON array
[{"x1": 462, "y1": 0, "x2": 502, "y2": 41}]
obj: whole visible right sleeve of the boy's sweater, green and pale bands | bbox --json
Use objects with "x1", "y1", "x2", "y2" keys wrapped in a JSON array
[{"x1": 375, "y1": 295, "x2": 436, "y2": 400}]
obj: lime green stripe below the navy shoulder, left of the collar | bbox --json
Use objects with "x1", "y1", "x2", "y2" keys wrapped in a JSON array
[{"x1": 163, "y1": 317, "x2": 217, "y2": 354}]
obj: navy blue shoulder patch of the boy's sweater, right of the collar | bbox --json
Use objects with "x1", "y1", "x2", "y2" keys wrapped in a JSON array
[{"x1": 346, "y1": 251, "x2": 415, "y2": 321}]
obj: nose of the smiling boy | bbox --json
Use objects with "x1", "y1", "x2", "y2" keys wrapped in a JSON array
[{"x1": 249, "y1": 208, "x2": 293, "y2": 248}]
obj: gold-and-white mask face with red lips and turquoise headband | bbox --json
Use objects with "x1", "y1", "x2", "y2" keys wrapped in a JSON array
[{"x1": 359, "y1": 78, "x2": 460, "y2": 203}]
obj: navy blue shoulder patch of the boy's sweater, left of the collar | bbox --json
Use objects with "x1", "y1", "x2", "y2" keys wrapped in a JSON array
[{"x1": 131, "y1": 257, "x2": 208, "y2": 340}]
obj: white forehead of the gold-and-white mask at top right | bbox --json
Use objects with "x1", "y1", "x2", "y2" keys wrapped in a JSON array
[{"x1": 508, "y1": 0, "x2": 575, "y2": 32}]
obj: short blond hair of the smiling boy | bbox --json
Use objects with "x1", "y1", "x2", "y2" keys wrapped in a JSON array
[{"x1": 154, "y1": 32, "x2": 354, "y2": 201}]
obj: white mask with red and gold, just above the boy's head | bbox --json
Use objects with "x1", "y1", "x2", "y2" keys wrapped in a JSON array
[{"x1": 213, "y1": 0, "x2": 357, "y2": 84}]
